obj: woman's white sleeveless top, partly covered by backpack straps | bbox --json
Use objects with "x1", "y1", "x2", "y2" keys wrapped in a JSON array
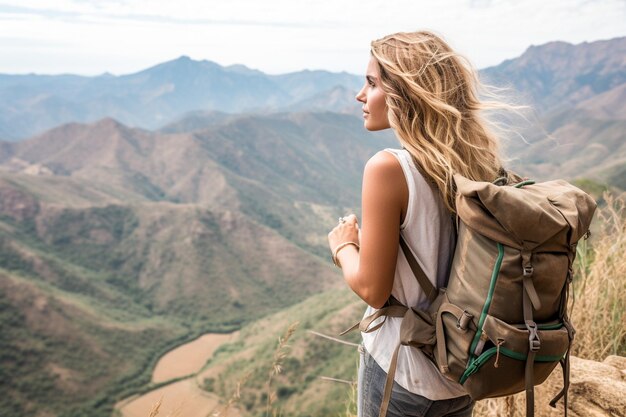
[{"x1": 362, "y1": 149, "x2": 467, "y2": 400}]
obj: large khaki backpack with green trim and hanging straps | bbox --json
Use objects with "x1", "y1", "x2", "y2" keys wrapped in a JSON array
[{"x1": 346, "y1": 175, "x2": 596, "y2": 417}]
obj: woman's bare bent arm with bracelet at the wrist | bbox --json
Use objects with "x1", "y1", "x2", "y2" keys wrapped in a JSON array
[{"x1": 328, "y1": 151, "x2": 409, "y2": 308}]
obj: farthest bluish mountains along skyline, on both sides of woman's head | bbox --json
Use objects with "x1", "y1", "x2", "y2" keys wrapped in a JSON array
[{"x1": 0, "y1": 38, "x2": 626, "y2": 140}]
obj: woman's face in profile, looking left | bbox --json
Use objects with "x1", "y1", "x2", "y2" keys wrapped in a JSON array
[{"x1": 356, "y1": 57, "x2": 390, "y2": 131}]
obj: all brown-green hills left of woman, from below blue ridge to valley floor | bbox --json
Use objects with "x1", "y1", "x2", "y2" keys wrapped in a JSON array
[{"x1": 0, "y1": 114, "x2": 391, "y2": 417}]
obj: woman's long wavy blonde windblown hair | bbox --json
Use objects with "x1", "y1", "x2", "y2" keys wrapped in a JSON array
[{"x1": 371, "y1": 31, "x2": 506, "y2": 213}]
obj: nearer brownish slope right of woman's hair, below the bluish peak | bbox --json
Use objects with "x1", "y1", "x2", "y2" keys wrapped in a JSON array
[{"x1": 508, "y1": 92, "x2": 626, "y2": 187}]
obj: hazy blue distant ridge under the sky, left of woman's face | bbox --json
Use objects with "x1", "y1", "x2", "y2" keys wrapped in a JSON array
[{"x1": 0, "y1": 56, "x2": 360, "y2": 140}]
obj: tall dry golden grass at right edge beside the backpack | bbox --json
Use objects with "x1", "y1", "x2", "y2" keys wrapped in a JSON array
[{"x1": 570, "y1": 194, "x2": 626, "y2": 360}]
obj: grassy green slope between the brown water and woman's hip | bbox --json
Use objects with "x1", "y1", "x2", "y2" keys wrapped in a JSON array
[{"x1": 196, "y1": 289, "x2": 365, "y2": 417}]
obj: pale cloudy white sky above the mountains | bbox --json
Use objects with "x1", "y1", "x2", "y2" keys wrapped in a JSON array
[{"x1": 0, "y1": 0, "x2": 626, "y2": 75}]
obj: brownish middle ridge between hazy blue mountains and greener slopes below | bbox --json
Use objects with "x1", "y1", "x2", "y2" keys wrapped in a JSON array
[{"x1": 0, "y1": 112, "x2": 395, "y2": 208}]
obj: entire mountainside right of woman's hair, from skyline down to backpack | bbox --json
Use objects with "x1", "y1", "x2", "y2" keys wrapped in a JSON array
[{"x1": 482, "y1": 38, "x2": 626, "y2": 190}]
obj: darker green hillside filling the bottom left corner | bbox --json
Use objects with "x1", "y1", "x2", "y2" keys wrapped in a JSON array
[{"x1": 0, "y1": 258, "x2": 189, "y2": 416}]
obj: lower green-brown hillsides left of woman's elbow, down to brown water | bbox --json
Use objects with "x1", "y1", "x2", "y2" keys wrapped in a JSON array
[{"x1": 0, "y1": 183, "x2": 336, "y2": 416}]
